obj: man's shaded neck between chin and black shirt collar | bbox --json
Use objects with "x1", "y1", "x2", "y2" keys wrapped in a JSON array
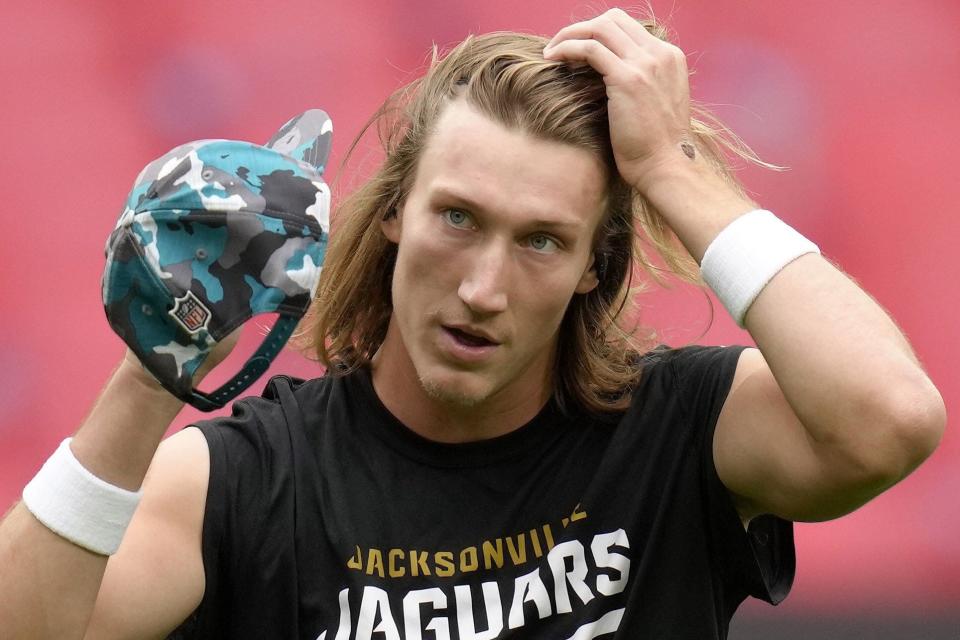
[{"x1": 371, "y1": 323, "x2": 552, "y2": 443}]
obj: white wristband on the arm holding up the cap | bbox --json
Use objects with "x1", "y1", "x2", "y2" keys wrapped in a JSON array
[{"x1": 23, "y1": 438, "x2": 143, "y2": 556}]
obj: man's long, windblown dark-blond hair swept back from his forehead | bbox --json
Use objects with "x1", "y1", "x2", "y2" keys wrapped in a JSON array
[{"x1": 302, "y1": 20, "x2": 769, "y2": 412}]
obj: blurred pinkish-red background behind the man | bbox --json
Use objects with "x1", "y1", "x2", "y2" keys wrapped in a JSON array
[{"x1": 0, "y1": 0, "x2": 960, "y2": 638}]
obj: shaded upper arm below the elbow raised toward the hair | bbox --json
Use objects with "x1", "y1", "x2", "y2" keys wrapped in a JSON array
[{"x1": 713, "y1": 349, "x2": 879, "y2": 521}]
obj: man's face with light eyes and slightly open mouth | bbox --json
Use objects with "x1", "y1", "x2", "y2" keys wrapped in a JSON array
[{"x1": 383, "y1": 100, "x2": 605, "y2": 408}]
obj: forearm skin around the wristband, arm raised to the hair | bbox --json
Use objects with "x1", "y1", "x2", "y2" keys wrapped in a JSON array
[{"x1": 645, "y1": 163, "x2": 943, "y2": 479}]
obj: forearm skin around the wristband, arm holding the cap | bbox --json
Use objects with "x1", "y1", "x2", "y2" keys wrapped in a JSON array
[{"x1": 0, "y1": 361, "x2": 182, "y2": 638}]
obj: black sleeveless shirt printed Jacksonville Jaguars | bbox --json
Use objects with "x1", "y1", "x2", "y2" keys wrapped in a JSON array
[{"x1": 170, "y1": 347, "x2": 794, "y2": 640}]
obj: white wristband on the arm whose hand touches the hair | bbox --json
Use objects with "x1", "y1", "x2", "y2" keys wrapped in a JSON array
[{"x1": 700, "y1": 209, "x2": 820, "y2": 327}]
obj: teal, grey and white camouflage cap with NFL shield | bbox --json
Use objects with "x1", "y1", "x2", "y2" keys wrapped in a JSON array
[{"x1": 103, "y1": 109, "x2": 333, "y2": 411}]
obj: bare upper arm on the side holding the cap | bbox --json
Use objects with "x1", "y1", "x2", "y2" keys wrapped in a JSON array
[{"x1": 86, "y1": 428, "x2": 210, "y2": 639}]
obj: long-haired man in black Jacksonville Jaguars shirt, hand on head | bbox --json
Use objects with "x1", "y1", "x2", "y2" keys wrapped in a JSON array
[{"x1": 0, "y1": 9, "x2": 945, "y2": 640}]
